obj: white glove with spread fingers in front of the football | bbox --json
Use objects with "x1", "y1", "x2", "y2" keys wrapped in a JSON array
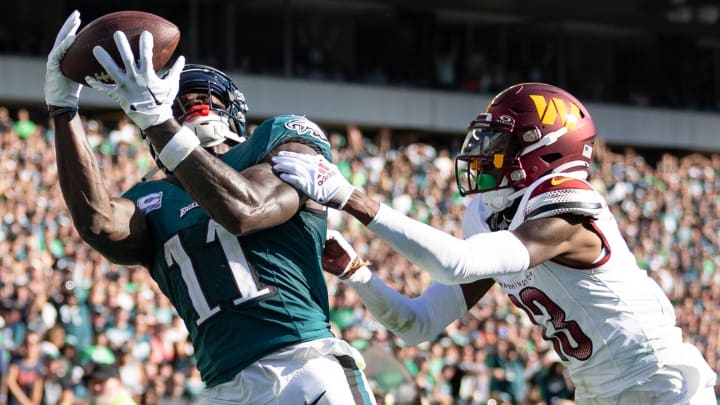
[{"x1": 85, "y1": 31, "x2": 185, "y2": 131}]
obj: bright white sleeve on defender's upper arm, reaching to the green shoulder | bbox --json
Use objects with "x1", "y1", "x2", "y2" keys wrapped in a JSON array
[{"x1": 367, "y1": 204, "x2": 530, "y2": 284}]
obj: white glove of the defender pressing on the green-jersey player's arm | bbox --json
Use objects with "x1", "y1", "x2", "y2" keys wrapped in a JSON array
[{"x1": 272, "y1": 151, "x2": 355, "y2": 209}]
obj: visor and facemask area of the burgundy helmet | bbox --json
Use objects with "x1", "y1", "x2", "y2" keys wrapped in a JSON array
[{"x1": 455, "y1": 128, "x2": 511, "y2": 196}]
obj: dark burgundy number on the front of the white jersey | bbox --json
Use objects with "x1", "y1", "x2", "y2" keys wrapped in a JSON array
[{"x1": 510, "y1": 287, "x2": 593, "y2": 361}]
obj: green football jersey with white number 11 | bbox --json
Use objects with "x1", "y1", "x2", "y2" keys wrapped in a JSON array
[{"x1": 124, "y1": 116, "x2": 333, "y2": 387}]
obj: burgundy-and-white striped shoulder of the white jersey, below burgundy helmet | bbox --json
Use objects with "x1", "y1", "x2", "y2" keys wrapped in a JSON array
[{"x1": 523, "y1": 174, "x2": 605, "y2": 221}]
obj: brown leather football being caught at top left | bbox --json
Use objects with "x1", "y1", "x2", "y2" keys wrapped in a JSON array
[{"x1": 60, "y1": 11, "x2": 180, "y2": 84}]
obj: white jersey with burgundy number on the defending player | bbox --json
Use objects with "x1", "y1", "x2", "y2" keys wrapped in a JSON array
[{"x1": 484, "y1": 174, "x2": 716, "y2": 398}]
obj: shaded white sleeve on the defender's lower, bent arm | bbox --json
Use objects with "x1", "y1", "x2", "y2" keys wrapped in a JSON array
[{"x1": 343, "y1": 267, "x2": 467, "y2": 345}]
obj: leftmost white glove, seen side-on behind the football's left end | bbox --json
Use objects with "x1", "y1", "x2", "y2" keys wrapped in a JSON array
[{"x1": 45, "y1": 10, "x2": 82, "y2": 108}]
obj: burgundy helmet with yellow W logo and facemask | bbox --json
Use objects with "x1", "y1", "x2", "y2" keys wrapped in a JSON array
[{"x1": 455, "y1": 83, "x2": 595, "y2": 195}]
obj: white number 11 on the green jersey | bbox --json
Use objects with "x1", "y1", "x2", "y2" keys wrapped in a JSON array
[{"x1": 165, "y1": 220, "x2": 274, "y2": 326}]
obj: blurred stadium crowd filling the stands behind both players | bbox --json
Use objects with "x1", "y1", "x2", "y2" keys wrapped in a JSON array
[{"x1": 0, "y1": 107, "x2": 720, "y2": 405}]
